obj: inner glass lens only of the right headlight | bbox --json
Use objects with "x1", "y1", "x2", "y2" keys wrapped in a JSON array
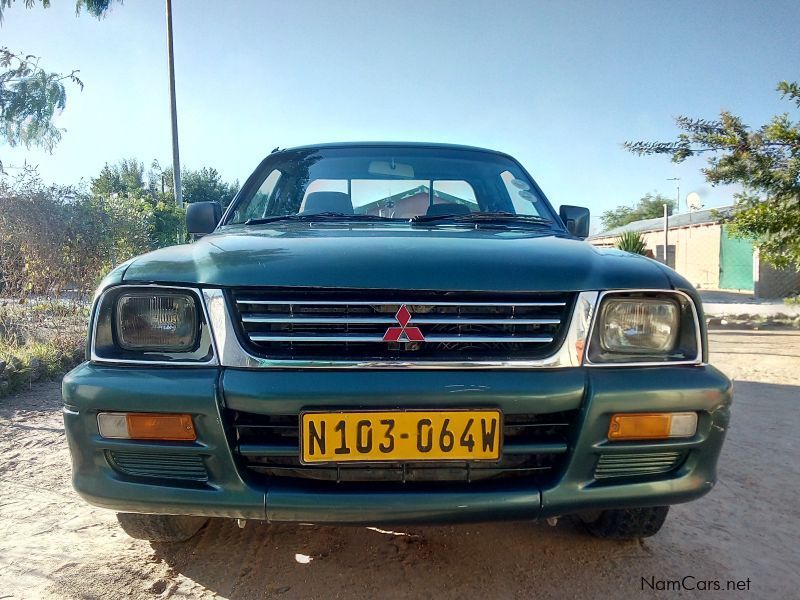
[{"x1": 599, "y1": 298, "x2": 679, "y2": 354}]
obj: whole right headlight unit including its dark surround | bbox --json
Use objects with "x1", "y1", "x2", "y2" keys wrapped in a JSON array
[{"x1": 585, "y1": 290, "x2": 702, "y2": 365}]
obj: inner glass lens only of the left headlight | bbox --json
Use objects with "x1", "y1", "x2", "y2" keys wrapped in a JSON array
[{"x1": 116, "y1": 292, "x2": 199, "y2": 352}]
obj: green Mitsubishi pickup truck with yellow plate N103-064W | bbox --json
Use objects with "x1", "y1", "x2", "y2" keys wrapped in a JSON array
[{"x1": 63, "y1": 143, "x2": 731, "y2": 541}]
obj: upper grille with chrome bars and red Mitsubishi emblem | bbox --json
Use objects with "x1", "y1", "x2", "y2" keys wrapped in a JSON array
[{"x1": 231, "y1": 289, "x2": 574, "y2": 361}]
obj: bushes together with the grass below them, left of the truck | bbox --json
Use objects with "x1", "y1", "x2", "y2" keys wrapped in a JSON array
[{"x1": 0, "y1": 171, "x2": 183, "y2": 395}]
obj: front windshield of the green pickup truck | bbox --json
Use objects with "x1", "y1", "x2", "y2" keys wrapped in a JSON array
[{"x1": 225, "y1": 146, "x2": 552, "y2": 224}]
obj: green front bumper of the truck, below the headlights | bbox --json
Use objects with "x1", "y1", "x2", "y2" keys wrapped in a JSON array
[{"x1": 63, "y1": 363, "x2": 731, "y2": 524}]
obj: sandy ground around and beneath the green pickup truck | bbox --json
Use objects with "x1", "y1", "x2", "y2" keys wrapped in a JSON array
[{"x1": 0, "y1": 331, "x2": 800, "y2": 598}]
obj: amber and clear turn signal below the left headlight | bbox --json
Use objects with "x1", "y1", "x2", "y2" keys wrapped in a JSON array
[{"x1": 97, "y1": 413, "x2": 197, "y2": 442}]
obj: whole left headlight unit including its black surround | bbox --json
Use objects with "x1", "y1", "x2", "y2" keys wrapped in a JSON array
[{"x1": 90, "y1": 285, "x2": 215, "y2": 364}]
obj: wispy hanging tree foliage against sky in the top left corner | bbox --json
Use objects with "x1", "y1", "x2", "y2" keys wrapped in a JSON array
[{"x1": 0, "y1": 0, "x2": 121, "y2": 166}]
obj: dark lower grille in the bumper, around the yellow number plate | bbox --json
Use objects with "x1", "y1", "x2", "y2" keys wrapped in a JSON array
[{"x1": 227, "y1": 411, "x2": 577, "y2": 485}]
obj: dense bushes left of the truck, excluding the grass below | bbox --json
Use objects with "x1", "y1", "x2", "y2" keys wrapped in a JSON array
[{"x1": 0, "y1": 173, "x2": 183, "y2": 297}]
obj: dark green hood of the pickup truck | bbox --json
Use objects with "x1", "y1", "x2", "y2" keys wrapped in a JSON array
[{"x1": 123, "y1": 223, "x2": 672, "y2": 291}]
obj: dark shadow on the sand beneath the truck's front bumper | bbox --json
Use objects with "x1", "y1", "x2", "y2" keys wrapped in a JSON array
[{"x1": 152, "y1": 519, "x2": 651, "y2": 598}]
